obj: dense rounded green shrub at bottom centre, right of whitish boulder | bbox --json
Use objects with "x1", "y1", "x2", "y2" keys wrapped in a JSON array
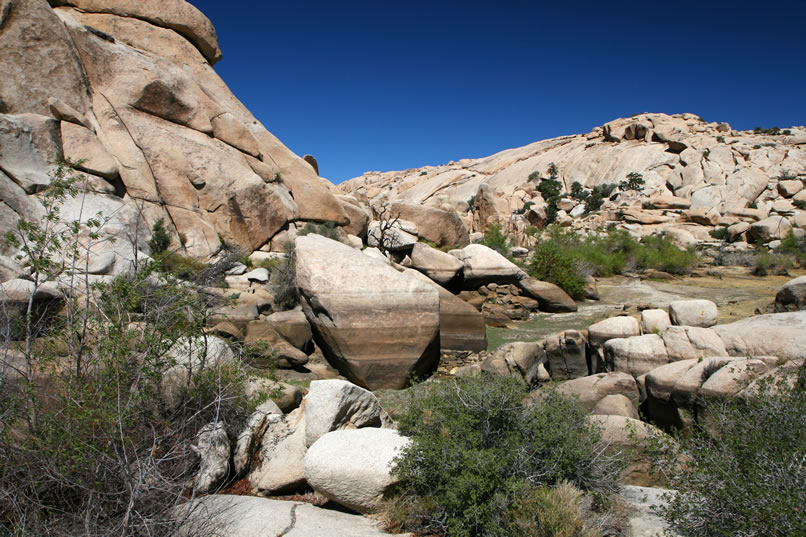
[{"x1": 392, "y1": 375, "x2": 621, "y2": 537}]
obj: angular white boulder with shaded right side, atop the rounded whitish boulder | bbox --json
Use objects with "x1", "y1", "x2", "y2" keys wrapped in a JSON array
[{"x1": 305, "y1": 379, "x2": 382, "y2": 447}]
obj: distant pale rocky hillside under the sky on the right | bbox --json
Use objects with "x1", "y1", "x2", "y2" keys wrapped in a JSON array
[{"x1": 339, "y1": 114, "x2": 806, "y2": 243}]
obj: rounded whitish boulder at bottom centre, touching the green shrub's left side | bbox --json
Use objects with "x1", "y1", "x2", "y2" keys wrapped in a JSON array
[{"x1": 305, "y1": 428, "x2": 409, "y2": 513}]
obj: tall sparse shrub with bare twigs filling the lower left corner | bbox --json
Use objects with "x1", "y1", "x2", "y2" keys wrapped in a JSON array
[{"x1": 0, "y1": 165, "x2": 266, "y2": 536}]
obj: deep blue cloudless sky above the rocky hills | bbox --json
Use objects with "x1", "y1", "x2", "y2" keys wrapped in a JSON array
[{"x1": 190, "y1": 0, "x2": 806, "y2": 183}]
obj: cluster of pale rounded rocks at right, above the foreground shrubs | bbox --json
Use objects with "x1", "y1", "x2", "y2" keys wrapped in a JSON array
[{"x1": 460, "y1": 284, "x2": 806, "y2": 444}]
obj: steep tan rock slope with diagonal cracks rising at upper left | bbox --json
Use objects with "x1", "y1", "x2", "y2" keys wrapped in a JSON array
[{"x1": 0, "y1": 0, "x2": 349, "y2": 279}]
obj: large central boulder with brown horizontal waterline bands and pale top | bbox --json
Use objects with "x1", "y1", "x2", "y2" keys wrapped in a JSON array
[{"x1": 296, "y1": 235, "x2": 439, "y2": 389}]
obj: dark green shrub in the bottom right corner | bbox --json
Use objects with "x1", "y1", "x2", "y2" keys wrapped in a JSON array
[{"x1": 656, "y1": 365, "x2": 806, "y2": 537}]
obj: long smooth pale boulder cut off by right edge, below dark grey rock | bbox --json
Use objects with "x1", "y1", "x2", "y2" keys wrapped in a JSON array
[{"x1": 712, "y1": 311, "x2": 806, "y2": 359}]
